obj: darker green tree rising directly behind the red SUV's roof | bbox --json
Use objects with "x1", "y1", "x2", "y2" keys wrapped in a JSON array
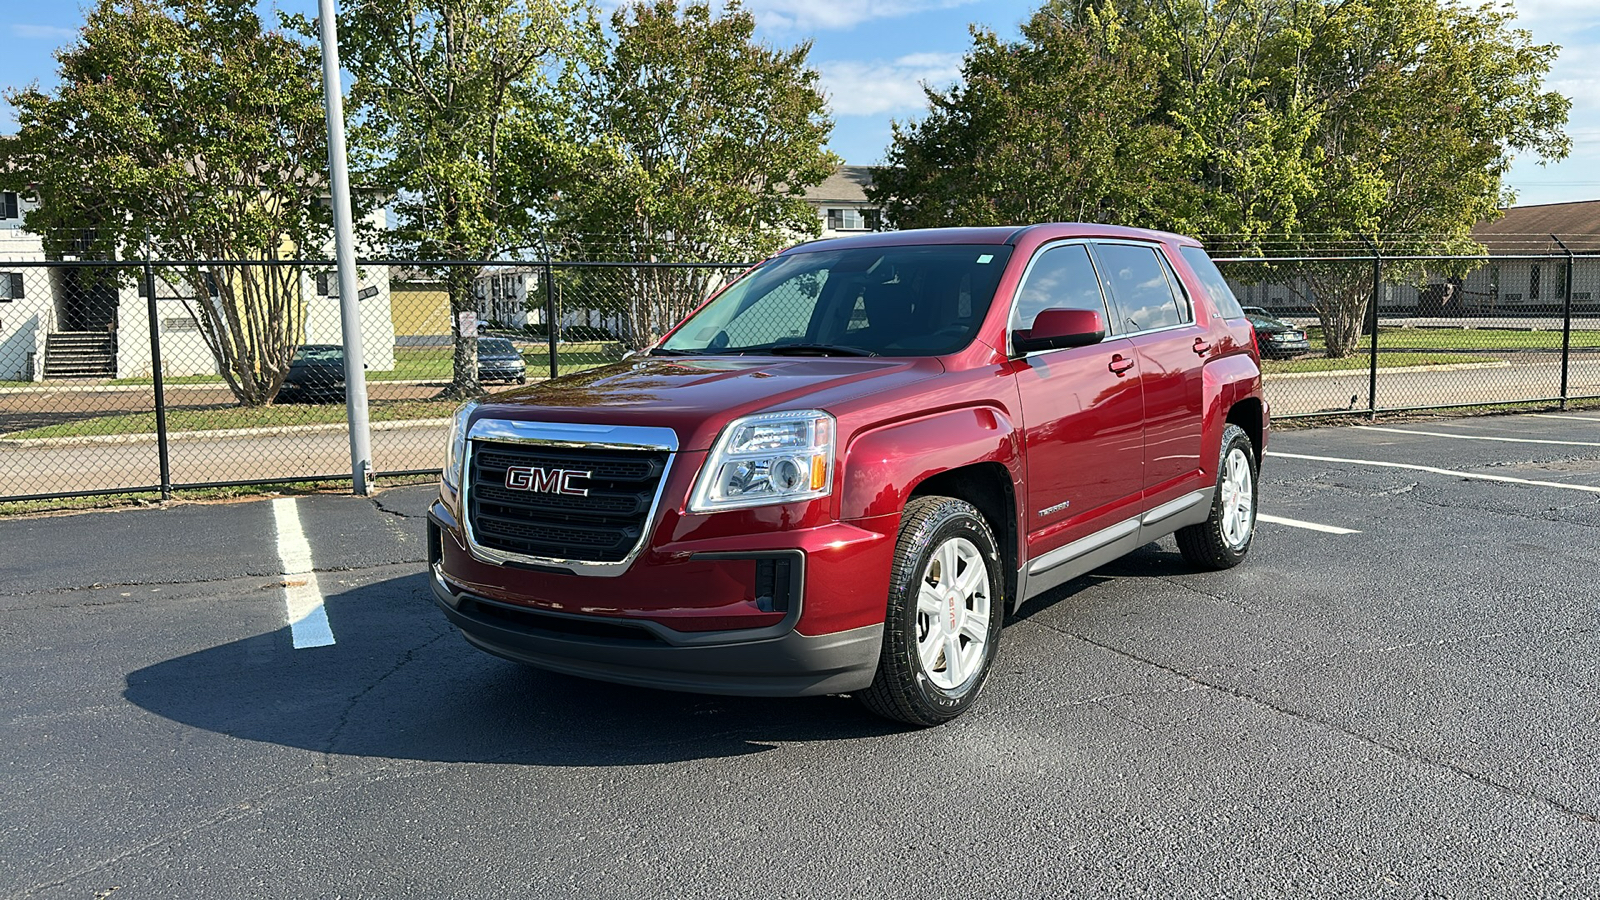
[{"x1": 867, "y1": 6, "x2": 1194, "y2": 227}]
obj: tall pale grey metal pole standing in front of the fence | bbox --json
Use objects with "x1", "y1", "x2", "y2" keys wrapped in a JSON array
[{"x1": 317, "y1": 0, "x2": 373, "y2": 496}]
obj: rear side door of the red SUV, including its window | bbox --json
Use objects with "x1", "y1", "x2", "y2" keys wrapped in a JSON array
[{"x1": 1094, "y1": 240, "x2": 1211, "y2": 508}]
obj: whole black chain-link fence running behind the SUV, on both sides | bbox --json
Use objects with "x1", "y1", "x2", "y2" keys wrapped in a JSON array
[{"x1": 0, "y1": 253, "x2": 1600, "y2": 501}]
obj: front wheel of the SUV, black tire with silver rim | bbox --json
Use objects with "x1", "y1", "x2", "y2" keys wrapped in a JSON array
[{"x1": 856, "y1": 496, "x2": 1005, "y2": 727}]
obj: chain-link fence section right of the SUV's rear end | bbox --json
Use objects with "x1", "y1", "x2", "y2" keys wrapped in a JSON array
[{"x1": 1218, "y1": 253, "x2": 1600, "y2": 418}]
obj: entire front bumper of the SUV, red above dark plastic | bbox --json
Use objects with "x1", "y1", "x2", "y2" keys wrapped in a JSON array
[{"x1": 429, "y1": 501, "x2": 893, "y2": 697}]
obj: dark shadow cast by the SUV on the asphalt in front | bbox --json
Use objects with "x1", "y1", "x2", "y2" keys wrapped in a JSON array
[{"x1": 123, "y1": 573, "x2": 906, "y2": 765}]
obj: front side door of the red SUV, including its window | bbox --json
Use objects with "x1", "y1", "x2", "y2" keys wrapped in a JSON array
[{"x1": 1010, "y1": 240, "x2": 1144, "y2": 560}]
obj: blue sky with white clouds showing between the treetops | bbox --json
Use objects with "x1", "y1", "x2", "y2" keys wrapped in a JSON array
[{"x1": 0, "y1": 0, "x2": 1600, "y2": 203}]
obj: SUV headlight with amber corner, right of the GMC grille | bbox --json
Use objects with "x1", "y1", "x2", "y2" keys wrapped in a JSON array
[{"x1": 690, "y1": 410, "x2": 834, "y2": 512}]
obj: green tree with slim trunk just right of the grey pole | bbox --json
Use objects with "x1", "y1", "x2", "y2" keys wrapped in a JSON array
[{"x1": 326, "y1": 0, "x2": 594, "y2": 397}]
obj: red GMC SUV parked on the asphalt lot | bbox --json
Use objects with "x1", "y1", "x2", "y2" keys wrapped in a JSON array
[{"x1": 429, "y1": 224, "x2": 1267, "y2": 725}]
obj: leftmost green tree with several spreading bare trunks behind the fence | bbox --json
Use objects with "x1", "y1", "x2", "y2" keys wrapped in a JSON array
[{"x1": 0, "y1": 0, "x2": 328, "y2": 398}]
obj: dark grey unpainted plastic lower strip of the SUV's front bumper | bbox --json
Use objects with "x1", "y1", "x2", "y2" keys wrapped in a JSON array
[{"x1": 429, "y1": 562, "x2": 883, "y2": 697}]
